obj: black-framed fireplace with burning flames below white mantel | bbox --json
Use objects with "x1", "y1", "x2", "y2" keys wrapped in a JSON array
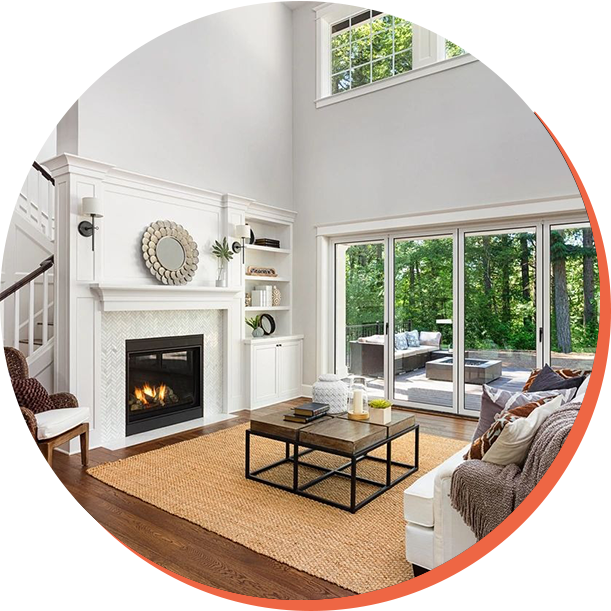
[{"x1": 125, "y1": 335, "x2": 204, "y2": 436}]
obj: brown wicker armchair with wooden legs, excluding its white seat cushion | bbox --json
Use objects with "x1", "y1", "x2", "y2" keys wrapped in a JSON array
[{"x1": 4, "y1": 347, "x2": 89, "y2": 467}]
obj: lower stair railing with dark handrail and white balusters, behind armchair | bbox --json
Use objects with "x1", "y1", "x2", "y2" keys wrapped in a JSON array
[{"x1": 0, "y1": 256, "x2": 54, "y2": 358}]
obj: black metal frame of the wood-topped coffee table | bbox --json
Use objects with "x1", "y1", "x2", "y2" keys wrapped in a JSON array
[{"x1": 245, "y1": 424, "x2": 420, "y2": 513}]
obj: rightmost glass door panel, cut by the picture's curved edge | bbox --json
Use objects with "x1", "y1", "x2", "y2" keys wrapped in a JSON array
[{"x1": 550, "y1": 224, "x2": 600, "y2": 369}]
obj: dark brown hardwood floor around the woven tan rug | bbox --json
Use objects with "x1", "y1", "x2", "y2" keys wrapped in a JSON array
[{"x1": 54, "y1": 399, "x2": 476, "y2": 600}]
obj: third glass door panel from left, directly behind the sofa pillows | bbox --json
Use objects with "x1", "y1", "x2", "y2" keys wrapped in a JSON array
[{"x1": 463, "y1": 230, "x2": 538, "y2": 414}]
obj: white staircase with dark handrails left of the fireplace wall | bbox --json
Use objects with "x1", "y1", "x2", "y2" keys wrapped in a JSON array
[{"x1": 0, "y1": 162, "x2": 55, "y2": 391}]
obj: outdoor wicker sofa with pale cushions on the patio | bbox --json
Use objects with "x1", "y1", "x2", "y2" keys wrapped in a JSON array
[{"x1": 350, "y1": 331, "x2": 441, "y2": 378}]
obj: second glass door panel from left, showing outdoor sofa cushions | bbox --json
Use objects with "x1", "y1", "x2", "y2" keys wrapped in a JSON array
[{"x1": 389, "y1": 236, "x2": 455, "y2": 411}]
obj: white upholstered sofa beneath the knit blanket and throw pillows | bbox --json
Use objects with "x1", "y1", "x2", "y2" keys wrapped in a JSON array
[{"x1": 403, "y1": 381, "x2": 587, "y2": 575}]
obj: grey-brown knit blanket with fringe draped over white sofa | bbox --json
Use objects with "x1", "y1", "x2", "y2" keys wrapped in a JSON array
[{"x1": 450, "y1": 403, "x2": 581, "y2": 541}]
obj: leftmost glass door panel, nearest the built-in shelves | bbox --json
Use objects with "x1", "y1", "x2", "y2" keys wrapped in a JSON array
[{"x1": 335, "y1": 240, "x2": 386, "y2": 399}]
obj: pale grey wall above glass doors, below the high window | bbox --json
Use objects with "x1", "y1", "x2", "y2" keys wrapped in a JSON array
[{"x1": 293, "y1": 6, "x2": 578, "y2": 384}]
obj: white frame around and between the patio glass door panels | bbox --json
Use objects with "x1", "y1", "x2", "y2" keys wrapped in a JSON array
[{"x1": 330, "y1": 210, "x2": 590, "y2": 417}]
